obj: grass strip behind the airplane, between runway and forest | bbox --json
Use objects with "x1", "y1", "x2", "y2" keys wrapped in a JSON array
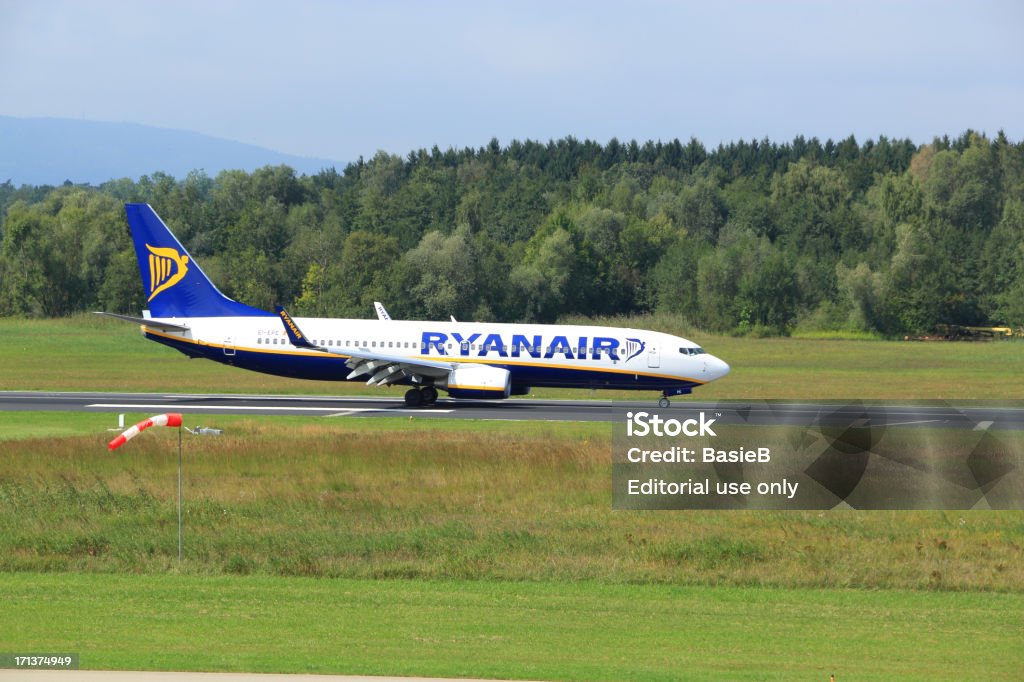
[{"x1": 0, "y1": 315, "x2": 1024, "y2": 400}]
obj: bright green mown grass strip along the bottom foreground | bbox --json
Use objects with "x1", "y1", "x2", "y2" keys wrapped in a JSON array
[{"x1": 0, "y1": 573, "x2": 1024, "y2": 682}]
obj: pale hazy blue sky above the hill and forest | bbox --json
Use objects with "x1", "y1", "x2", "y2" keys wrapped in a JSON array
[{"x1": 0, "y1": 0, "x2": 1024, "y2": 162}]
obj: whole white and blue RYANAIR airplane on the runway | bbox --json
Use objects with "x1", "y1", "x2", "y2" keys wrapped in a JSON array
[{"x1": 98, "y1": 204, "x2": 729, "y2": 408}]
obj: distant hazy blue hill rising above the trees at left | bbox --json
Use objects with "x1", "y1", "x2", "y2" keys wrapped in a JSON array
[{"x1": 0, "y1": 116, "x2": 345, "y2": 185}]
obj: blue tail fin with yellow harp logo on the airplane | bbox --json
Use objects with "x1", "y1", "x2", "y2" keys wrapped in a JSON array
[{"x1": 125, "y1": 204, "x2": 273, "y2": 317}]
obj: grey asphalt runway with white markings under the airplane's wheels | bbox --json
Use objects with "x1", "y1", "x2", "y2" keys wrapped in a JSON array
[{"x1": 0, "y1": 391, "x2": 1024, "y2": 430}]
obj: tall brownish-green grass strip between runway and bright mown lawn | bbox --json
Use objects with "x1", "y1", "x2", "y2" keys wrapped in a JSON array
[{"x1": 0, "y1": 415, "x2": 1024, "y2": 592}]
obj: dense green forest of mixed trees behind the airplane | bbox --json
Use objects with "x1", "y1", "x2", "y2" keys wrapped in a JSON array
[{"x1": 0, "y1": 131, "x2": 1024, "y2": 337}]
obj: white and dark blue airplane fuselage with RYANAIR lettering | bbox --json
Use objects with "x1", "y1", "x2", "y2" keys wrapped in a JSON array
[{"x1": 143, "y1": 316, "x2": 729, "y2": 392}]
